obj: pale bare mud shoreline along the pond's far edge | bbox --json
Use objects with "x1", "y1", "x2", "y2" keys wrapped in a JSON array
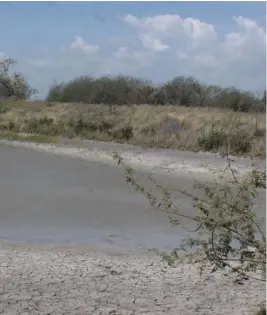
[{"x1": 0, "y1": 139, "x2": 265, "y2": 180}]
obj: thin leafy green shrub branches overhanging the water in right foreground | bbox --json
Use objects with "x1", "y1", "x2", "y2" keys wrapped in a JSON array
[{"x1": 113, "y1": 122, "x2": 266, "y2": 281}]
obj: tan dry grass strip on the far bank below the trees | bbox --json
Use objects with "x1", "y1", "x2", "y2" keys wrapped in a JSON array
[{"x1": 0, "y1": 101, "x2": 266, "y2": 156}]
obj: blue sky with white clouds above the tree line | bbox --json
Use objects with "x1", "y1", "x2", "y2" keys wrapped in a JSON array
[{"x1": 0, "y1": 1, "x2": 266, "y2": 99}]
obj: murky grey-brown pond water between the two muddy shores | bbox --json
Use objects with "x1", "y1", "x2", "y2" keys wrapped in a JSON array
[{"x1": 0, "y1": 145, "x2": 265, "y2": 253}]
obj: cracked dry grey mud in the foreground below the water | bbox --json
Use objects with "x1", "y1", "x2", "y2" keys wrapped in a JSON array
[{"x1": 0, "y1": 245, "x2": 265, "y2": 315}]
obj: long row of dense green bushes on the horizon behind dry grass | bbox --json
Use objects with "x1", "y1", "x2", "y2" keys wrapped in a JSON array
[{"x1": 47, "y1": 76, "x2": 266, "y2": 112}]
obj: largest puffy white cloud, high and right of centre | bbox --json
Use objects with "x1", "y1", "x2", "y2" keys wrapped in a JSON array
[{"x1": 119, "y1": 14, "x2": 220, "y2": 70}]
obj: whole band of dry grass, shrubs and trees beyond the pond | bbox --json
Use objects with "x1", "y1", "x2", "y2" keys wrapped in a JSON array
[{"x1": 0, "y1": 59, "x2": 266, "y2": 157}]
